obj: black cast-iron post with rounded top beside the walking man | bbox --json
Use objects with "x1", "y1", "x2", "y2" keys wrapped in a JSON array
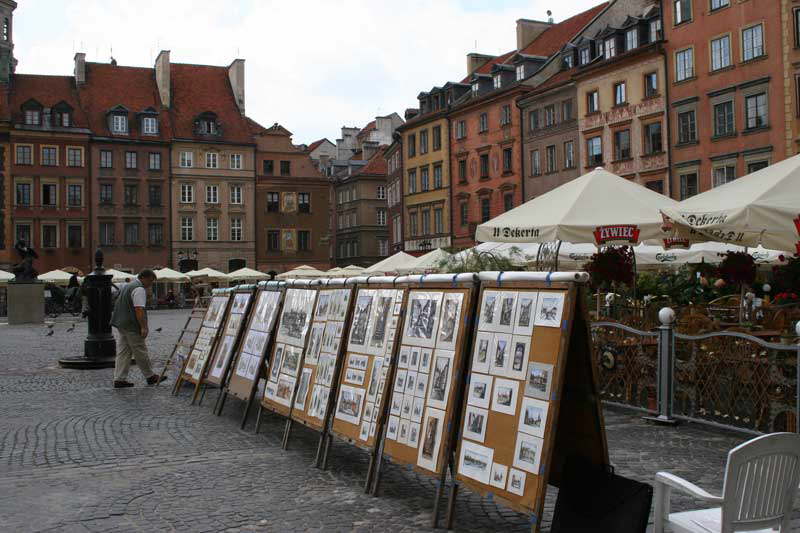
[{"x1": 58, "y1": 249, "x2": 117, "y2": 369}]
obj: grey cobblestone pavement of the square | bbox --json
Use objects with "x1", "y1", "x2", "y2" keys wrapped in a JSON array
[{"x1": 0, "y1": 311, "x2": 800, "y2": 532}]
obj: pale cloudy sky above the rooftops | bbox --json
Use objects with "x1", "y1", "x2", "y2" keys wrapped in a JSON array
[{"x1": 13, "y1": 0, "x2": 600, "y2": 144}]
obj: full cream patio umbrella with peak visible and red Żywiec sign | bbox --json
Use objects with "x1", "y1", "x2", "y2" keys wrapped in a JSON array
[{"x1": 475, "y1": 168, "x2": 677, "y2": 246}]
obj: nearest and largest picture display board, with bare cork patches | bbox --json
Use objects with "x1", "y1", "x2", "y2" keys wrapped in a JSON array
[{"x1": 446, "y1": 272, "x2": 608, "y2": 532}]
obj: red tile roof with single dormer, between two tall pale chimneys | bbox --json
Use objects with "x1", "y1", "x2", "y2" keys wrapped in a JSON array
[{"x1": 170, "y1": 63, "x2": 252, "y2": 144}]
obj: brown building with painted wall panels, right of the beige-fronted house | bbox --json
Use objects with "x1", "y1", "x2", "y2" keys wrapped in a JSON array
[{"x1": 255, "y1": 120, "x2": 331, "y2": 273}]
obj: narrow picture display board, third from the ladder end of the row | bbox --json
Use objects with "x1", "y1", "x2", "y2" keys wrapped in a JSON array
[{"x1": 217, "y1": 281, "x2": 285, "y2": 428}]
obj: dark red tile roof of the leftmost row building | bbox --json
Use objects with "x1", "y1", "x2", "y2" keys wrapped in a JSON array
[{"x1": 11, "y1": 74, "x2": 89, "y2": 128}]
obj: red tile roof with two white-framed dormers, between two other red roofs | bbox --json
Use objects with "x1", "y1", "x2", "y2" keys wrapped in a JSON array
[{"x1": 78, "y1": 62, "x2": 172, "y2": 140}]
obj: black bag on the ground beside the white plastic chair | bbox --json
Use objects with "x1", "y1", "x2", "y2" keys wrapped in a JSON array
[{"x1": 550, "y1": 459, "x2": 653, "y2": 533}]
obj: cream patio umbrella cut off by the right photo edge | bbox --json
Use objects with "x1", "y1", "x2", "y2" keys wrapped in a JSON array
[{"x1": 661, "y1": 155, "x2": 800, "y2": 253}]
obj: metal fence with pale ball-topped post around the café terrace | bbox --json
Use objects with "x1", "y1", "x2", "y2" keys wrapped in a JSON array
[{"x1": 592, "y1": 310, "x2": 800, "y2": 433}]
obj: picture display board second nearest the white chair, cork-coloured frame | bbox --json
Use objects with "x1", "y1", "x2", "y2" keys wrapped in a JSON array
[{"x1": 375, "y1": 273, "x2": 478, "y2": 520}]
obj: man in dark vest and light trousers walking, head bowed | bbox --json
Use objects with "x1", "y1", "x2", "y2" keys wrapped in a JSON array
[{"x1": 111, "y1": 269, "x2": 167, "y2": 389}]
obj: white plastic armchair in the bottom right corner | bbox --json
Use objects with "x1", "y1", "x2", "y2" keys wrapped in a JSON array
[{"x1": 654, "y1": 433, "x2": 800, "y2": 533}]
